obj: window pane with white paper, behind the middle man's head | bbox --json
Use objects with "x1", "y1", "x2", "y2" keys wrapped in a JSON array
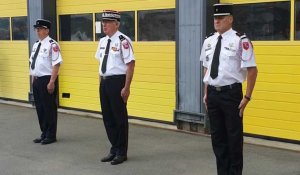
[{"x1": 95, "y1": 11, "x2": 135, "y2": 41}]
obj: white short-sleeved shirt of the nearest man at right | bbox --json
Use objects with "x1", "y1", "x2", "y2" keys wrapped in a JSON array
[{"x1": 200, "y1": 29, "x2": 256, "y2": 87}]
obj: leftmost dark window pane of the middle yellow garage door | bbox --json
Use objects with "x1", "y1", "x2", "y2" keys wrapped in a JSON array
[{"x1": 59, "y1": 14, "x2": 93, "y2": 41}]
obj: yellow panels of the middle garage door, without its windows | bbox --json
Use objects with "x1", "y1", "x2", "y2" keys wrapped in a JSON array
[{"x1": 57, "y1": 0, "x2": 176, "y2": 122}]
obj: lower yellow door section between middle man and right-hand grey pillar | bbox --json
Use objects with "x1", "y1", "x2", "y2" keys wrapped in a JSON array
[{"x1": 128, "y1": 42, "x2": 176, "y2": 121}]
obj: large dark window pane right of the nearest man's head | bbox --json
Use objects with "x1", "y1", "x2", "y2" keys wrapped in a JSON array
[{"x1": 233, "y1": 1, "x2": 291, "y2": 40}]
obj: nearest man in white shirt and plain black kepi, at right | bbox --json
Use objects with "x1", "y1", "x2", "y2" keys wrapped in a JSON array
[{"x1": 200, "y1": 4, "x2": 257, "y2": 175}]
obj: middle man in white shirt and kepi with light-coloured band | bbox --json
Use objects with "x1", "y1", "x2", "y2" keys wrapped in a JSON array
[{"x1": 95, "y1": 10, "x2": 135, "y2": 165}]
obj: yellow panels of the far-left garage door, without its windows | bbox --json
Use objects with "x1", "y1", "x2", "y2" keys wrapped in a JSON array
[{"x1": 0, "y1": 0, "x2": 30, "y2": 100}]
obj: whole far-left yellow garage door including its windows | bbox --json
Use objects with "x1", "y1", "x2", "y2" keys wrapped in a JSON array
[{"x1": 0, "y1": 0, "x2": 30, "y2": 101}]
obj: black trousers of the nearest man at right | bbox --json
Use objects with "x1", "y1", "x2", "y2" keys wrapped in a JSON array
[{"x1": 207, "y1": 84, "x2": 243, "y2": 175}]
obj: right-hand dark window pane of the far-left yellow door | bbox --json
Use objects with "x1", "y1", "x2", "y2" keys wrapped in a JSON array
[{"x1": 11, "y1": 16, "x2": 28, "y2": 40}]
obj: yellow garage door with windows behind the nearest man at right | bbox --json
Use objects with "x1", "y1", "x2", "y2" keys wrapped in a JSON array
[{"x1": 221, "y1": 0, "x2": 300, "y2": 141}]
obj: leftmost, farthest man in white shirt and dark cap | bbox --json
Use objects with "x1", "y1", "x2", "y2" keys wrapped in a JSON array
[{"x1": 29, "y1": 19, "x2": 62, "y2": 145}]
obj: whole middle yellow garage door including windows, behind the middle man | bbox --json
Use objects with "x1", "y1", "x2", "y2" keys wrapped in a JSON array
[{"x1": 57, "y1": 0, "x2": 175, "y2": 122}]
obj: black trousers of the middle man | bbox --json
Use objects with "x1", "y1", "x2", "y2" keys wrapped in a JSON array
[{"x1": 99, "y1": 75, "x2": 128, "y2": 156}]
